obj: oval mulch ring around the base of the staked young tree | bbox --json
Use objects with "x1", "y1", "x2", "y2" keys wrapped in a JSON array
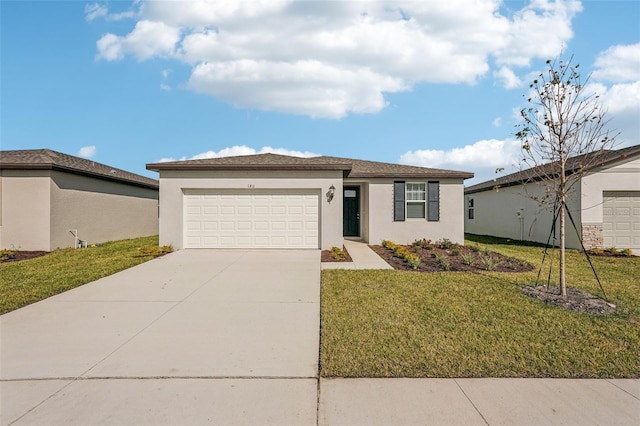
[{"x1": 522, "y1": 285, "x2": 616, "y2": 315}]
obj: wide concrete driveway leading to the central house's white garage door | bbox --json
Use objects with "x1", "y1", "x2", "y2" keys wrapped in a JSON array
[{"x1": 0, "y1": 250, "x2": 320, "y2": 425}]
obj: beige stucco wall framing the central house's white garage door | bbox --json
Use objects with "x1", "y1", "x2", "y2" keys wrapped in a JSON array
[{"x1": 160, "y1": 170, "x2": 342, "y2": 250}]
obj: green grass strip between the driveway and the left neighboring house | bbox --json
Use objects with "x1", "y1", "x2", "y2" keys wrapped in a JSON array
[{"x1": 0, "y1": 236, "x2": 158, "y2": 314}]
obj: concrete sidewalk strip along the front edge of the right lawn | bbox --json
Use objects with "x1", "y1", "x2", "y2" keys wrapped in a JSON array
[{"x1": 318, "y1": 379, "x2": 640, "y2": 426}]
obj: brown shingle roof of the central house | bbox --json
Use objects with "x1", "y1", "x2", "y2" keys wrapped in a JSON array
[{"x1": 147, "y1": 153, "x2": 473, "y2": 179}]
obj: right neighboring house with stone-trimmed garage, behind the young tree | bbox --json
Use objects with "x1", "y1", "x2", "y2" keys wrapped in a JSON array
[{"x1": 465, "y1": 145, "x2": 640, "y2": 250}]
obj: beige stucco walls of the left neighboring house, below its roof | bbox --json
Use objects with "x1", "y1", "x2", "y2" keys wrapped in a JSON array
[{"x1": 0, "y1": 170, "x2": 158, "y2": 251}]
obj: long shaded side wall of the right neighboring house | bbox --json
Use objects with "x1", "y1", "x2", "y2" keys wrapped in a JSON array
[{"x1": 464, "y1": 184, "x2": 582, "y2": 248}]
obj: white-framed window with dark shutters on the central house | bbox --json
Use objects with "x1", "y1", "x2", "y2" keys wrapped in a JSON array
[{"x1": 393, "y1": 181, "x2": 440, "y2": 222}]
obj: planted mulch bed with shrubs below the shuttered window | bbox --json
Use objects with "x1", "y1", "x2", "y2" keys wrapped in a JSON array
[{"x1": 369, "y1": 245, "x2": 533, "y2": 272}]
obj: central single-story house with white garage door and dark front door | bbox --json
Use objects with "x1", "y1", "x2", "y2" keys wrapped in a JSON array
[{"x1": 147, "y1": 154, "x2": 473, "y2": 249}]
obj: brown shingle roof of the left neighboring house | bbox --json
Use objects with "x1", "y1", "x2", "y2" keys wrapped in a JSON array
[{"x1": 0, "y1": 149, "x2": 158, "y2": 189}]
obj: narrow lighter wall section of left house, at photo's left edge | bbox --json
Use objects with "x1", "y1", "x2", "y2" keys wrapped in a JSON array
[{"x1": 0, "y1": 170, "x2": 51, "y2": 251}]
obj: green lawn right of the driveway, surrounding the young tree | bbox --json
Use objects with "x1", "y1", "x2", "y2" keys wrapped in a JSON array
[{"x1": 320, "y1": 236, "x2": 640, "y2": 377}]
